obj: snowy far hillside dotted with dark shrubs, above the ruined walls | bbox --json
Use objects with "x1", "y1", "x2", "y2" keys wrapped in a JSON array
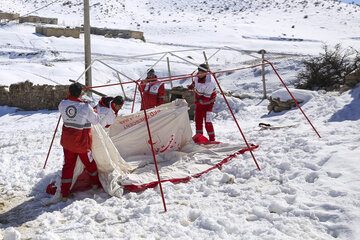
[{"x1": 1, "y1": 0, "x2": 360, "y2": 45}]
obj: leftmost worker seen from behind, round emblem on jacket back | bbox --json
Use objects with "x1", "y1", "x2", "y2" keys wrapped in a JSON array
[{"x1": 59, "y1": 83, "x2": 100, "y2": 202}]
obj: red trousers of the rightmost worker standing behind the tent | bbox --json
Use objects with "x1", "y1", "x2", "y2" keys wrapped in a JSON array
[{"x1": 195, "y1": 103, "x2": 215, "y2": 141}]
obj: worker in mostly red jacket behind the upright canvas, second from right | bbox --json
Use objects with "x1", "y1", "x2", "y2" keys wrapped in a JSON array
[{"x1": 139, "y1": 69, "x2": 165, "y2": 110}]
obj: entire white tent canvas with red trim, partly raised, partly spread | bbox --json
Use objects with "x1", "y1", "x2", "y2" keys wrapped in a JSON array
[{"x1": 45, "y1": 99, "x2": 253, "y2": 202}]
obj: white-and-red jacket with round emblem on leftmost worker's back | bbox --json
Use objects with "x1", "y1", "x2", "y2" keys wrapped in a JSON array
[{"x1": 59, "y1": 96, "x2": 100, "y2": 153}]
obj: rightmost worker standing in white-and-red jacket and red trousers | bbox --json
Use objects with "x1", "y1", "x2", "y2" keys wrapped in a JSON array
[{"x1": 182, "y1": 64, "x2": 216, "y2": 142}]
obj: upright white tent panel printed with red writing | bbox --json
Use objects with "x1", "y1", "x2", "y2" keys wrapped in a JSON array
[{"x1": 109, "y1": 99, "x2": 192, "y2": 158}]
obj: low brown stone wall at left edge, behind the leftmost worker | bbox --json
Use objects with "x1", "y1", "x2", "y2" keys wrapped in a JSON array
[{"x1": 0, "y1": 81, "x2": 69, "y2": 111}]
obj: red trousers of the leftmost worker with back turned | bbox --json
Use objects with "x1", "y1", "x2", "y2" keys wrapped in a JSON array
[{"x1": 61, "y1": 148, "x2": 99, "y2": 197}]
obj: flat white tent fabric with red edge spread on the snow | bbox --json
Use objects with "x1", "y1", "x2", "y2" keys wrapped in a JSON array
[{"x1": 119, "y1": 142, "x2": 255, "y2": 191}]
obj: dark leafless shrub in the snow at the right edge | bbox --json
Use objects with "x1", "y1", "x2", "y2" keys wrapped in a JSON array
[{"x1": 296, "y1": 44, "x2": 360, "y2": 91}]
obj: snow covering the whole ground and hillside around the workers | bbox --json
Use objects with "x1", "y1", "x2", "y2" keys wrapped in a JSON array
[{"x1": 0, "y1": 0, "x2": 360, "y2": 240}]
